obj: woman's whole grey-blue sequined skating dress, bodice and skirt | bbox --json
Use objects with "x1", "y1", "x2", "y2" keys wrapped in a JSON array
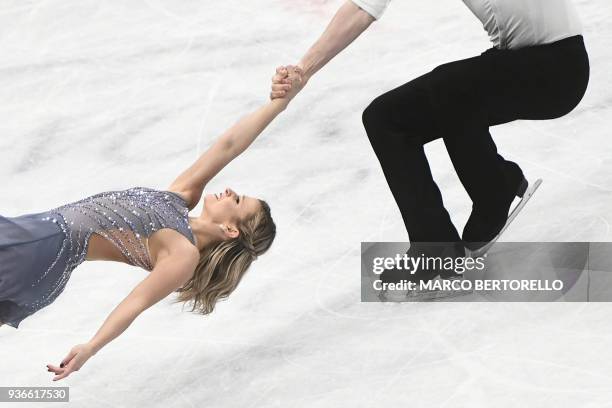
[{"x1": 0, "y1": 187, "x2": 195, "y2": 328}]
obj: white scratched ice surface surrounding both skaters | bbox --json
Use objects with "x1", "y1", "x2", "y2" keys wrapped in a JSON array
[{"x1": 0, "y1": 0, "x2": 612, "y2": 408}]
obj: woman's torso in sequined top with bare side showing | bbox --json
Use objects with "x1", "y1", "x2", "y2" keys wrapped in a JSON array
[{"x1": 44, "y1": 187, "x2": 196, "y2": 270}]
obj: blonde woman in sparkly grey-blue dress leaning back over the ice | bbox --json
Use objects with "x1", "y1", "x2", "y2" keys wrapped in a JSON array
[{"x1": 0, "y1": 67, "x2": 299, "y2": 380}]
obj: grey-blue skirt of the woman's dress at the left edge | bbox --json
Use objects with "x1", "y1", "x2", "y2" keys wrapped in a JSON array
[{"x1": 0, "y1": 212, "x2": 69, "y2": 328}]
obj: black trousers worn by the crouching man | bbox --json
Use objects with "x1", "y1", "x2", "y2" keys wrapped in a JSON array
[{"x1": 363, "y1": 36, "x2": 589, "y2": 242}]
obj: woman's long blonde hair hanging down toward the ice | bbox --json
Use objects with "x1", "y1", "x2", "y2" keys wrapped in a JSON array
[{"x1": 175, "y1": 200, "x2": 276, "y2": 314}]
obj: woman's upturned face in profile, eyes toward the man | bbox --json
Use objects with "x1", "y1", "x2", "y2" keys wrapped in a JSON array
[{"x1": 204, "y1": 188, "x2": 260, "y2": 224}]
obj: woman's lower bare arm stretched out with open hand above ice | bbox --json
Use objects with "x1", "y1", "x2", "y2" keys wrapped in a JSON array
[{"x1": 47, "y1": 245, "x2": 200, "y2": 381}]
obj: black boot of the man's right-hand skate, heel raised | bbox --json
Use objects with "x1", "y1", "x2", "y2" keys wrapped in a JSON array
[{"x1": 462, "y1": 161, "x2": 528, "y2": 252}]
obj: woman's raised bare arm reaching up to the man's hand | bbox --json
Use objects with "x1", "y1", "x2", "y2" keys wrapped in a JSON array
[{"x1": 169, "y1": 69, "x2": 301, "y2": 209}]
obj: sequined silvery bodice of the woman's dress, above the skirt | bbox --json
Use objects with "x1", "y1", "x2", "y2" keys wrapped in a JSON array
[{"x1": 41, "y1": 187, "x2": 195, "y2": 271}]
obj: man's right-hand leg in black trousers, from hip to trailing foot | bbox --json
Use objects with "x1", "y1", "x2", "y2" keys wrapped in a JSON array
[{"x1": 430, "y1": 37, "x2": 588, "y2": 242}]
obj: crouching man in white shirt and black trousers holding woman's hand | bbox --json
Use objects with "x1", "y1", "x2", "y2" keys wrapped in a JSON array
[{"x1": 270, "y1": 0, "x2": 589, "y2": 288}]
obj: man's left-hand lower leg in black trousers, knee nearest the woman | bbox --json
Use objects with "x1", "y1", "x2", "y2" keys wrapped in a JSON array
[{"x1": 363, "y1": 75, "x2": 460, "y2": 242}]
